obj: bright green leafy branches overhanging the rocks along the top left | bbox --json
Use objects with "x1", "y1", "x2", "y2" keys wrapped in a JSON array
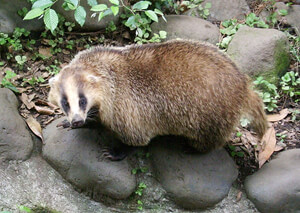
[{"x1": 24, "y1": 0, "x2": 165, "y2": 43}]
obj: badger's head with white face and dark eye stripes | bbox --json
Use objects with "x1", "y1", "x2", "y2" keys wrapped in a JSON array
[{"x1": 48, "y1": 66, "x2": 99, "y2": 128}]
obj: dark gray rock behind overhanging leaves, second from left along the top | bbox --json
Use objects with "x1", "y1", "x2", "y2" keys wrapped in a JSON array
[{"x1": 53, "y1": 0, "x2": 122, "y2": 31}]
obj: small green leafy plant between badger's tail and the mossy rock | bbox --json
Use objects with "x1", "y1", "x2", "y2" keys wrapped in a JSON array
[{"x1": 253, "y1": 76, "x2": 279, "y2": 112}]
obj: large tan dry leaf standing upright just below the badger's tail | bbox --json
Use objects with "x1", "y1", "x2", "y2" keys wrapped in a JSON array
[{"x1": 258, "y1": 126, "x2": 276, "y2": 168}]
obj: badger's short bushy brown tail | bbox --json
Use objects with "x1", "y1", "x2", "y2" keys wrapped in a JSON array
[{"x1": 243, "y1": 88, "x2": 268, "y2": 139}]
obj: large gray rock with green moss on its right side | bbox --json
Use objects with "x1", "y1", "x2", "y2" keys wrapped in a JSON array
[{"x1": 227, "y1": 26, "x2": 290, "y2": 83}]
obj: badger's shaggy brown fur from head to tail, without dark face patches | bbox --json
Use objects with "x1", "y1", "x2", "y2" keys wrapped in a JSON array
[{"x1": 49, "y1": 40, "x2": 267, "y2": 151}]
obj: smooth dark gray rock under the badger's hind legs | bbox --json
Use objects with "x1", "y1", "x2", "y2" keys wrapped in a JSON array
[{"x1": 150, "y1": 138, "x2": 238, "y2": 209}]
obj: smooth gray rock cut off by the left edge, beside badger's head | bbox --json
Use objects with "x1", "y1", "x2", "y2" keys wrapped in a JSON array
[{"x1": 0, "y1": 89, "x2": 33, "y2": 161}]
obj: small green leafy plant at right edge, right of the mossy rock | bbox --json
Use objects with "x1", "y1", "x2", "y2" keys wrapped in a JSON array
[{"x1": 280, "y1": 71, "x2": 300, "y2": 102}]
